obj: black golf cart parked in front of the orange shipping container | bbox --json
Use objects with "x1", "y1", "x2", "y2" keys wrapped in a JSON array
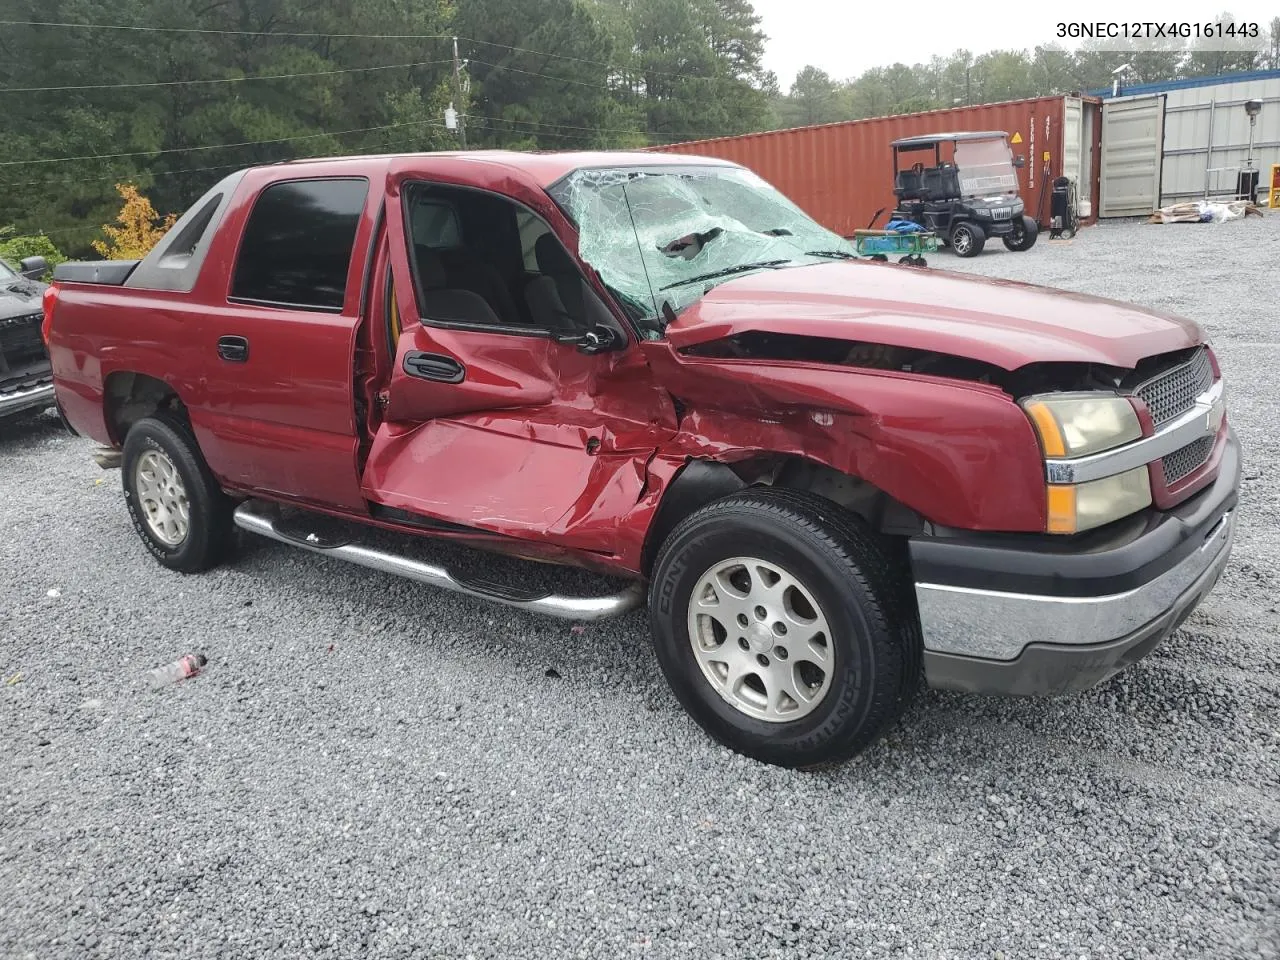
[{"x1": 891, "y1": 131, "x2": 1039, "y2": 257}]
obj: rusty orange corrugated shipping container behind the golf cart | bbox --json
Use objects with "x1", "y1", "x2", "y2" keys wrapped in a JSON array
[{"x1": 649, "y1": 96, "x2": 1102, "y2": 237}]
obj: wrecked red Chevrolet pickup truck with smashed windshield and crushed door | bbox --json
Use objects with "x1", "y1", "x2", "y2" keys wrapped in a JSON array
[{"x1": 44, "y1": 151, "x2": 1240, "y2": 767}]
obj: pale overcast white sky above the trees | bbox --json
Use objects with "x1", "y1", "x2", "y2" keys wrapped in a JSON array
[{"x1": 753, "y1": 0, "x2": 1280, "y2": 91}]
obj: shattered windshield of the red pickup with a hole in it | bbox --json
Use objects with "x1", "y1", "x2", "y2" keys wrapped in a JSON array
[{"x1": 552, "y1": 166, "x2": 855, "y2": 337}]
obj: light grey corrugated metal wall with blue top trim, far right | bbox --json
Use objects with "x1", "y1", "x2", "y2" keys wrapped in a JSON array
[{"x1": 1160, "y1": 77, "x2": 1280, "y2": 206}]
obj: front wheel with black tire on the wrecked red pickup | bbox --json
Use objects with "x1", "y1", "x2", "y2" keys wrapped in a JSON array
[{"x1": 649, "y1": 488, "x2": 923, "y2": 768}]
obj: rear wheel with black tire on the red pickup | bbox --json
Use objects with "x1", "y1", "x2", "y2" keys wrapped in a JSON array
[{"x1": 120, "y1": 412, "x2": 236, "y2": 573}]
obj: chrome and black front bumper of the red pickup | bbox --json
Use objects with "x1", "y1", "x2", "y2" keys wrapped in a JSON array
[{"x1": 910, "y1": 433, "x2": 1240, "y2": 696}]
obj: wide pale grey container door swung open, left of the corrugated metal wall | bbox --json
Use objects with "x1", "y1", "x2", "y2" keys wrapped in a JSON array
[{"x1": 1098, "y1": 93, "x2": 1165, "y2": 216}]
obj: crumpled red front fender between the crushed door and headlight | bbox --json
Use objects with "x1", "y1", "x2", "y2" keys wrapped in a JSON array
[{"x1": 641, "y1": 342, "x2": 1046, "y2": 532}]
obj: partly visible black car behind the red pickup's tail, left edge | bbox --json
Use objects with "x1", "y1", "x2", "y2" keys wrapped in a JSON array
[{"x1": 0, "y1": 257, "x2": 54, "y2": 419}]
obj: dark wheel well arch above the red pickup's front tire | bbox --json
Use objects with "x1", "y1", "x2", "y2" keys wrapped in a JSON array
[{"x1": 643, "y1": 453, "x2": 925, "y2": 576}]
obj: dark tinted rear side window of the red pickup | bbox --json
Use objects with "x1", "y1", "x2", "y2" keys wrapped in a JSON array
[{"x1": 230, "y1": 179, "x2": 369, "y2": 310}]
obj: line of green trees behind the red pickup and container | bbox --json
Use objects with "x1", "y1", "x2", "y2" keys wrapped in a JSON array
[{"x1": 0, "y1": 0, "x2": 1280, "y2": 256}]
